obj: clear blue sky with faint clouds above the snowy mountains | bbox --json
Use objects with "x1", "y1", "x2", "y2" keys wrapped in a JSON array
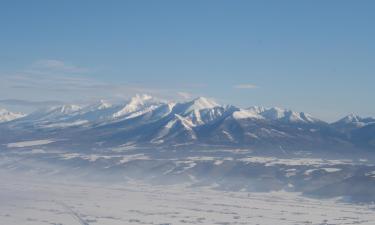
[{"x1": 0, "y1": 0, "x2": 375, "y2": 121}]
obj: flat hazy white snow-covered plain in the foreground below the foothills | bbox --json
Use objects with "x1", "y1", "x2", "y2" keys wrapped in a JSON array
[{"x1": 0, "y1": 173, "x2": 375, "y2": 225}]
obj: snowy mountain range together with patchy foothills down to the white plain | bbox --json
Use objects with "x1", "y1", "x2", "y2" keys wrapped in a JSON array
[{"x1": 0, "y1": 95, "x2": 375, "y2": 209}]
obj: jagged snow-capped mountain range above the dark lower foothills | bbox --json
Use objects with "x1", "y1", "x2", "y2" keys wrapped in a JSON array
[{"x1": 0, "y1": 95, "x2": 375, "y2": 150}]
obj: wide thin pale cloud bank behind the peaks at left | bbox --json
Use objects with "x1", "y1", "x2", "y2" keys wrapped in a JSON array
[{"x1": 0, "y1": 59, "x2": 206, "y2": 103}]
